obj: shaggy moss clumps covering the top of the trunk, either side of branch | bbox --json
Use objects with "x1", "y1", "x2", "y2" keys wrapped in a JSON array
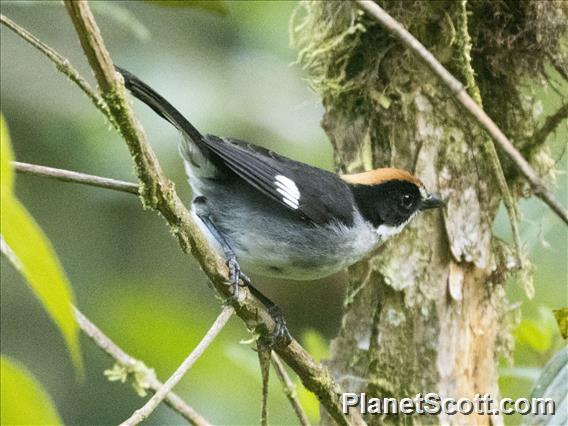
[{"x1": 291, "y1": 0, "x2": 568, "y2": 187}]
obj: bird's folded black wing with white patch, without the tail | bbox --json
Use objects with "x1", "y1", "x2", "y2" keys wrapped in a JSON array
[{"x1": 205, "y1": 135, "x2": 353, "y2": 225}]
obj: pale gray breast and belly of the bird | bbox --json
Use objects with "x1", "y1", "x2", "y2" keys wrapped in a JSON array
[{"x1": 192, "y1": 178, "x2": 379, "y2": 280}]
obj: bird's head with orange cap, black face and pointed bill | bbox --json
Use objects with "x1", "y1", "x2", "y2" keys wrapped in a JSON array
[{"x1": 342, "y1": 168, "x2": 444, "y2": 237}]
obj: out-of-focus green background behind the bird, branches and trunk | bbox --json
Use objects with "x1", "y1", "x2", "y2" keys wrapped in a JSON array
[{"x1": 0, "y1": 1, "x2": 568, "y2": 424}]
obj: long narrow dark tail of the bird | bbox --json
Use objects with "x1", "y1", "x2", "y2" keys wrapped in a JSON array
[{"x1": 115, "y1": 66, "x2": 206, "y2": 147}]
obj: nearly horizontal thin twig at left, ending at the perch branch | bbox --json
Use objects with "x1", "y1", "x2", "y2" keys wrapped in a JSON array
[{"x1": 12, "y1": 161, "x2": 138, "y2": 195}]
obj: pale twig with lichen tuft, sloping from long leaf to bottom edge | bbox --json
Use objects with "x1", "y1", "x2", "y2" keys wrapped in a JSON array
[{"x1": 74, "y1": 308, "x2": 209, "y2": 426}]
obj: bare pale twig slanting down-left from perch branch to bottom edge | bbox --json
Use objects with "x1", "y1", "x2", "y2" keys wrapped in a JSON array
[{"x1": 122, "y1": 306, "x2": 235, "y2": 426}]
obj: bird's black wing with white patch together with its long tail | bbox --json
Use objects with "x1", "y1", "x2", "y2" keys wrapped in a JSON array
[{"x1": 116, "y1": 67, "x2": 354, "y2": 224}]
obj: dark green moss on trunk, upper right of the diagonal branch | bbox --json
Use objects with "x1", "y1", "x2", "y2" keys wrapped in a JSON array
[{"x1": 468, "y1": 0, "x2": 568, "y2": 181}]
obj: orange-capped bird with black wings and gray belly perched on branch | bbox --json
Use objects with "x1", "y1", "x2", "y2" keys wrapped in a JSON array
[{"x1": 116, "y1": 67, "x2": 444, "y2": 345}]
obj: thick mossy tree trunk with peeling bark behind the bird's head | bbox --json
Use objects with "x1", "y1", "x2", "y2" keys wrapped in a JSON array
[{"x1": 294, "y1": 1, "x2": 566, "y2": 424}]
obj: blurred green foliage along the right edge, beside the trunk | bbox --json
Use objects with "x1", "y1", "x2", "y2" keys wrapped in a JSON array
[{"x1": 494, "y1": 70, "x2": 568, "y2": 425}]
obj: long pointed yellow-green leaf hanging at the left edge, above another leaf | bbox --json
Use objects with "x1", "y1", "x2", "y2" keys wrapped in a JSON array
[{"x1": 0, "y1": 118, "x2": 83, "y2": 376}]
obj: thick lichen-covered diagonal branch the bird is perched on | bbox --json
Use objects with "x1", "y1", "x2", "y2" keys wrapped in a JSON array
[{"x1": 61, "y1": 0, "x2": 364, "y2": 425}]
